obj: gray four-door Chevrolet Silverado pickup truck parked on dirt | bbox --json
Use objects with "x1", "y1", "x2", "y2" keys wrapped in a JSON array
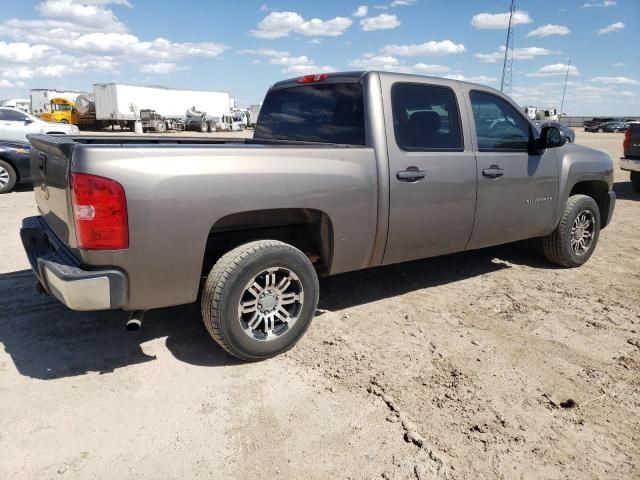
[{"x1": 21, "y1": 72, "x2": 615, "y2": 360}]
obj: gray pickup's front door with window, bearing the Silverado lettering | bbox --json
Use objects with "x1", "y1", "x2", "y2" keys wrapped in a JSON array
[{"x1": 468, "y1": 90, "x2": 559, "y2": 249}]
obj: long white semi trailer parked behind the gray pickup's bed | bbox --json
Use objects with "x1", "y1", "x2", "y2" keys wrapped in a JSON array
[{"x1": 93, "y1": 83, "x2": 230, "y2": 128}]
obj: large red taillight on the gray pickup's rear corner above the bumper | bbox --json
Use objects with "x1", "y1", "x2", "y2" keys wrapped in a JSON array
[{"x1": 71, "y1": 173, "x2": 129, "y2": 250}]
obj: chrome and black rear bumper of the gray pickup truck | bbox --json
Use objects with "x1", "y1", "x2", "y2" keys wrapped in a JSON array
[{"x1": 20, "y1": 217, "x2": 128, "y2": 311}]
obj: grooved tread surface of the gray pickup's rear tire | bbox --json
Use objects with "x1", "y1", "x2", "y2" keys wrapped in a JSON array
[{"x1": 201, "y1": 240, "x2": 317, "y2": 361}]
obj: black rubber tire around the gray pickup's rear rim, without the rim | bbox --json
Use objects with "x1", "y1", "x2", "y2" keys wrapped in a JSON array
[{"x1": 201, "y1": 240, "x2": 319, "y2": 361}]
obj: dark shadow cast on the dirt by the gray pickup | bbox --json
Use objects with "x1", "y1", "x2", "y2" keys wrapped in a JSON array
[{"x1": 0, "y1": 244, "x2": 548, "y2": 380}]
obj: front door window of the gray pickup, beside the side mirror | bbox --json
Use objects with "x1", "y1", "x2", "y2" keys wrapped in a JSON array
[{"x1": 470, "y1": 92, "x2": 530, "y2": 152}]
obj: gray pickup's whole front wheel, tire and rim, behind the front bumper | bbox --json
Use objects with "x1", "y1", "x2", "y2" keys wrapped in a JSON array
[{"x1": 542, "y1": 195, "x2": 600, "y2": 268}]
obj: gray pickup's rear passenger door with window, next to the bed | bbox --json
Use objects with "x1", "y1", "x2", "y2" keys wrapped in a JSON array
[{"x1": 381, "y1": 75, "x2": 476, "y2": 264}]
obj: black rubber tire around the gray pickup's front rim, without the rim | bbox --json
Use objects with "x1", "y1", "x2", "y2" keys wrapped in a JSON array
[{"x1": 542, "y1": 195, "x2": 600, "y2": 268}]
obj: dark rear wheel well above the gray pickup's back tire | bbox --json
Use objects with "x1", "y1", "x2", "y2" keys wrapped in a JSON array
[{"x1": 202, "y1": 208, "x2": 333, "y2": 276}]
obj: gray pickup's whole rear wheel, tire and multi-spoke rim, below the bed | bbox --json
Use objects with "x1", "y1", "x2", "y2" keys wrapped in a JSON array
[{"x1": 201, "y1": 240, "x2": 319, "y2": 361}]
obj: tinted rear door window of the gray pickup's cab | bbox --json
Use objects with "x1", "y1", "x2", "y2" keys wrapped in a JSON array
[{"x1": 391, "y1": 83, "x2": 463, "y2": 152}]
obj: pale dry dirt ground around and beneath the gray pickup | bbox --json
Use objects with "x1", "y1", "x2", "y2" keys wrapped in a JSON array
[{"x1": 0, "y1": 132, "x2": 640, "y2": 480}]
